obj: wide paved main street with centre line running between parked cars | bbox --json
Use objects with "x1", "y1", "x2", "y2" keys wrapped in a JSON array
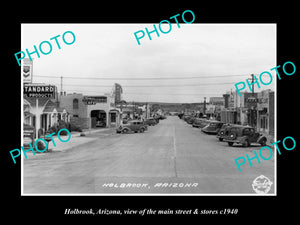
[{"x1": 23, "y1": 116, "x2": 275, "y2": 194}]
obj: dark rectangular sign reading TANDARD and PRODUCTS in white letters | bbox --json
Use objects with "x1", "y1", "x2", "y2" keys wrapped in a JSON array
[{"x1": 23, "y1": 84, "x2": 55, "y2": 98}]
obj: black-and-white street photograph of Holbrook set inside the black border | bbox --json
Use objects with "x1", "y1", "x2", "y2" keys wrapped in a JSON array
[{"x1": 20, "y1": 23, "x2": 276, "y2": 195}]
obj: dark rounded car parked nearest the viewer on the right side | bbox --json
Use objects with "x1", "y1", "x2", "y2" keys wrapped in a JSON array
[{"x1": 224, "y1": 125, "x2": 267, "y2": 147}]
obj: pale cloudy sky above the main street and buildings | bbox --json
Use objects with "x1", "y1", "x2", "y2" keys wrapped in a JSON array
[{"x1": 21, "y1": 22, "x2": 277, "y2": 103}]
